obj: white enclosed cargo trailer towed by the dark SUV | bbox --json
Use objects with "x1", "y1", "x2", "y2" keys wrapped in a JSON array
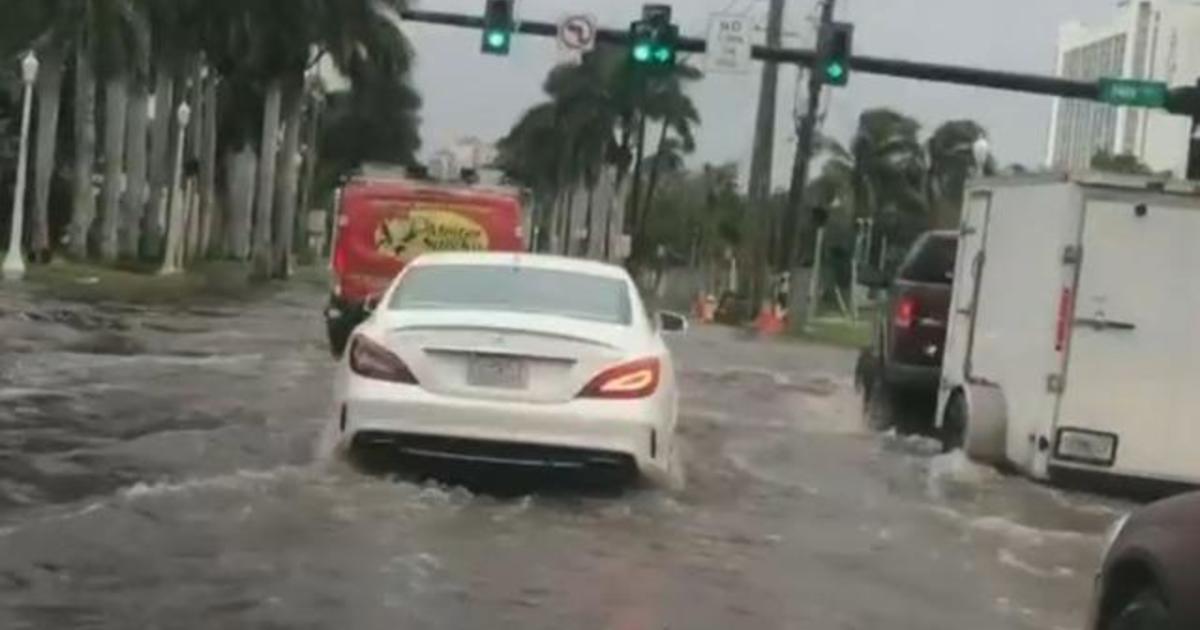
[{"x1": 936, "y1": 174, "x2": 1200, "y2": 484}]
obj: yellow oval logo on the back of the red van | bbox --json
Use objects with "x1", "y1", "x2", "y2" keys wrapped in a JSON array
[{"x1": 374, "y1": 209, "x2": 488, "y2": 260}]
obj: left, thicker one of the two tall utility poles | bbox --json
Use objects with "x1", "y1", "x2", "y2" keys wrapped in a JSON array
[{"x1": 749, "y1": 0, "x2": 784, "y2": 306}]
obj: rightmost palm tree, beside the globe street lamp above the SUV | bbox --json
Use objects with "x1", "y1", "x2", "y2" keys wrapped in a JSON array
[{"x1": 925, "y1": 120, "x2": 996, "y2": 228}]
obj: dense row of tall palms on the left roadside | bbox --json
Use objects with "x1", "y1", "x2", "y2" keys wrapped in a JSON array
[{"x1": 0, "y1": 0, "x2": 420, "y2": 277}]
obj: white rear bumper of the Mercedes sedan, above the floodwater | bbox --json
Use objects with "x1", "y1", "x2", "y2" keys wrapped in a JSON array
[{"x1": 341, "y1": 376, "x2": 674, "y2": 473}]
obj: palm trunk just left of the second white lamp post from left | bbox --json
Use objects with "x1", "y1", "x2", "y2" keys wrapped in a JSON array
[{"x1": 139, "y1": 67, "x2": 175, "y2": 258}]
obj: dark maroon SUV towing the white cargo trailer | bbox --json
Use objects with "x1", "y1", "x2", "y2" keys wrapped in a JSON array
[{"x1": 857, "y1": 230, "x2": 958, "y2": 428}]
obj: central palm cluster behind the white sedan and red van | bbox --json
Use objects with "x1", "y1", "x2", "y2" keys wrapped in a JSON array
[{"x1": 498, "y1": 46, "x2": 702, "y2": 260}]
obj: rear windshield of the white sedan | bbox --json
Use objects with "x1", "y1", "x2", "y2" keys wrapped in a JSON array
[{"x1": 389, "y1": 265, "x2": 632, "y2": 325}]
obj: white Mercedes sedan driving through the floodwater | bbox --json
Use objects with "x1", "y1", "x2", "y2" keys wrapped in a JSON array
[{"x1": 337, "y1": 253, "x2": 686, "y2": 479}]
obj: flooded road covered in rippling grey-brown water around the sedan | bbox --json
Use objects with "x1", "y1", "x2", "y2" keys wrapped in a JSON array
[{"x1": 0, "y1": 288, "x2": 1127, "y2": 630}]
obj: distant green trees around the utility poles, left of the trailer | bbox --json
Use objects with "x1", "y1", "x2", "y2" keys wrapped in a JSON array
[{"x1": 628, "y1": 108, "x2": 997, "y2": 295}]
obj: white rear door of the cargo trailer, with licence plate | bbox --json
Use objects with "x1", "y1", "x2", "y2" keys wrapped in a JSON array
[{"x1": 1051, "y1": 196, "x2": 1200, "y2": 481}]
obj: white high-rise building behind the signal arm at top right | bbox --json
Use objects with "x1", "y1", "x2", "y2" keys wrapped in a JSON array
[{"x1": 1046, "y1": 0, "x2": 1200, "y2": 176}]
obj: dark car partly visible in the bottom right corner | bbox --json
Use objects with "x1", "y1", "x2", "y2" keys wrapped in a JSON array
[{"x1": 1087, "y1": 492, "x2": 1200, "y2": 630}]
